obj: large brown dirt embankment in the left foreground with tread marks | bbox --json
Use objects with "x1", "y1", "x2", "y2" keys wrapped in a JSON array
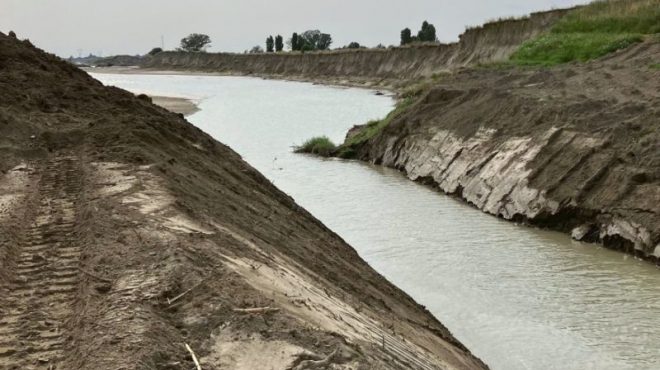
[{"x1": 0, "y1": 34, "x2": 486, "y2": 369}]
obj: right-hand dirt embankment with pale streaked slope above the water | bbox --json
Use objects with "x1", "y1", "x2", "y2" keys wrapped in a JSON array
[{"x1": 348, "y1": 41, "x2": 660, "y2": 261}]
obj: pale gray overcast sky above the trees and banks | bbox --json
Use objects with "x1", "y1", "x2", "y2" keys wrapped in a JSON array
[{"x1": 0, "y1": 0, "x2": 589, "y2": 57}]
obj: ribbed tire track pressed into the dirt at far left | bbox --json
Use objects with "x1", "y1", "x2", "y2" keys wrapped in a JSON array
[{"x1": 0, "y1": 155, "x2": 82, "y2": 370}]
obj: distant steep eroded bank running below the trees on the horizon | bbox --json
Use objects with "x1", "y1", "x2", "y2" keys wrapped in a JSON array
[{"x1": 142, "y1": 9, "x2": 569, "y2": 86}]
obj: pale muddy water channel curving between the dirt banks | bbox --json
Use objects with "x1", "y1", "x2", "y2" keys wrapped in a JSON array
[{"x1": 90, "y1": 75, "x2": 660, "y2": 370}]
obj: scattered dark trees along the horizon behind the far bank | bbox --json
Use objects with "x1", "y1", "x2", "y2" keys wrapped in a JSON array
[{"x1": 157, "y1": 21, "x2": 438, "y2": 55}]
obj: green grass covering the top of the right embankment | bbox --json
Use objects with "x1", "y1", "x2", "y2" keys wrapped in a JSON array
[{"x1": 511, "y1": 0, "x2": 660, "y2": 65}]
